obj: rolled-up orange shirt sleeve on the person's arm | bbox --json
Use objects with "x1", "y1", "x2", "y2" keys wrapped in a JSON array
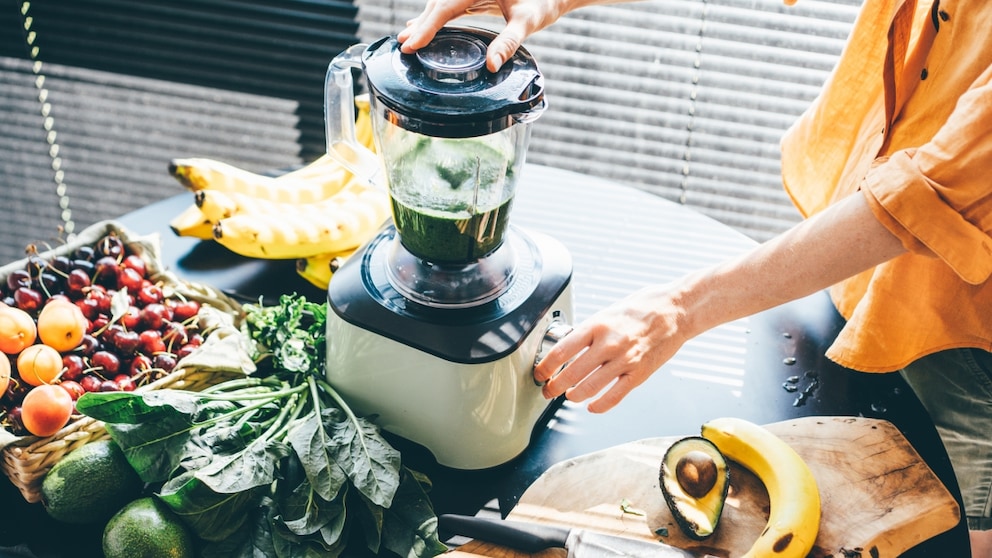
[{"x1": 862, "y1": 63, "x2": 992, "y2": 284}]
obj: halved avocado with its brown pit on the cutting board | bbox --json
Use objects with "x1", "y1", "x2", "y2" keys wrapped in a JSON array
[{"x1": 659, "y1": 436, "x2": 730, "y2": 541}]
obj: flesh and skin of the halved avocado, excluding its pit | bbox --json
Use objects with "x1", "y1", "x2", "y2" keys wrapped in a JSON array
[{"x1": 658, "y1": 436, "x2": 730, "y2": 541}]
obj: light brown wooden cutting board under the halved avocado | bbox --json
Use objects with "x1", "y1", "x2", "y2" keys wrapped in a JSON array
[{"x1": 447, "y1": 417, "x2": 960, "y2": 558}]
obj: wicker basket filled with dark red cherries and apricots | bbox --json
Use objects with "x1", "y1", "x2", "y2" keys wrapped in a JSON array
[{"x1": 0, "y1": 221, "x2": 253, "y2": 502}]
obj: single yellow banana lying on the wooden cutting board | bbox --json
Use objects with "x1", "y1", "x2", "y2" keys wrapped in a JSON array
[{"x1": 702, "y1": 417, "x2": 820, "y2": 558}]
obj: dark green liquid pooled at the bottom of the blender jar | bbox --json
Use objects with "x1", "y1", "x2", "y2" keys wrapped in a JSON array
[{"x1": 390, "y1": 198, "x2": 513, "y2": 264}]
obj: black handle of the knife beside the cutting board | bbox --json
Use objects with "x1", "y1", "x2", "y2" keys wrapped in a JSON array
[{"x1": 438, "y1": 514, "x2": 570, "y2": 554}]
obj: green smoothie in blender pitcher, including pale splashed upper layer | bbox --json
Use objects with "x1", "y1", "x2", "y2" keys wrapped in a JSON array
[{"x1": 389, "y1": 139, "x2": 513, "y2": 264}]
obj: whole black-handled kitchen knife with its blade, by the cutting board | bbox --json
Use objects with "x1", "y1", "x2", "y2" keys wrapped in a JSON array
[{"x1": 438, "y1": 514, "x2": 697, "y2": 558}]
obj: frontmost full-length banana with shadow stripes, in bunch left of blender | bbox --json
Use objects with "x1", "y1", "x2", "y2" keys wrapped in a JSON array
[{"x1": 214, "y1": 185, "x2": 389, "y2": 259}]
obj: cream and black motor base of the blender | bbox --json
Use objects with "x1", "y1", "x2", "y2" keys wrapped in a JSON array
[{"x1": 327, "y1": 229, "x2": 573, "y2": 469}]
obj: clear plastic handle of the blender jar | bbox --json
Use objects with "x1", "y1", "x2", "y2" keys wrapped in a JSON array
[{"x1": 324, "y1": 43, "x2": 383, "y2": 187}]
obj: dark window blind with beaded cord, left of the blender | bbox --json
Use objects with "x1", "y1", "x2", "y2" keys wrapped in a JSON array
[{"x1": 0, "y1": 0, "x2": 358, "y2": 262}]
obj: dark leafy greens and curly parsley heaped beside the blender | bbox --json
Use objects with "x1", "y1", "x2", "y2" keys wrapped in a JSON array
[{"x1": 77, "y1": 295, "x2": 446, "y2": 558}]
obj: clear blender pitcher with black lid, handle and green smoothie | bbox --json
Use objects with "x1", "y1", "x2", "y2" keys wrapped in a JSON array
[{"x1": 325, "y1": 28, "x2": 546, "y2": 304}]
